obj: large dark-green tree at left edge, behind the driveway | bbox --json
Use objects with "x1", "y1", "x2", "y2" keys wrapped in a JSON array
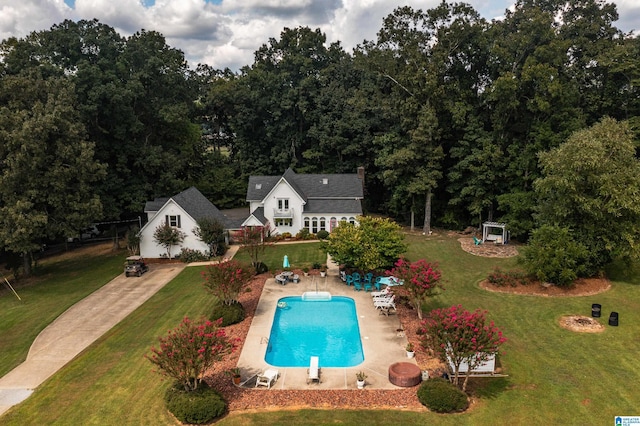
[{"x1": 0, "y1": 69, "x2": 105, "y2": 275}]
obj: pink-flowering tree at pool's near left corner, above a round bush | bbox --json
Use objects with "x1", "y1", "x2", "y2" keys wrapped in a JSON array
[{"x1": 145, "y1": 317, "x2": 235, "y2": 391}]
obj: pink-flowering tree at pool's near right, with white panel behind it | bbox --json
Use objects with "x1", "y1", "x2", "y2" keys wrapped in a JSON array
[{"x1": 420, "y1": 305, "x2": 507, "y2": 391}]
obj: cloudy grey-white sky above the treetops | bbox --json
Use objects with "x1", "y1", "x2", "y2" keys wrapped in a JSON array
[{"x1": 0, "y1": 0, "x2": 640, "y2": 71}]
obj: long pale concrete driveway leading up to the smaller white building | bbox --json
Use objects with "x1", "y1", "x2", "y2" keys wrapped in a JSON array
[{"x1": 0, "y1": 245, "x2": 238, "y2": 415}]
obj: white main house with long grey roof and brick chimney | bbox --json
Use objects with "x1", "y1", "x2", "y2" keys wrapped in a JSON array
[{"x1": 242, "y1": 168, "x2": 364, "y2": 235}]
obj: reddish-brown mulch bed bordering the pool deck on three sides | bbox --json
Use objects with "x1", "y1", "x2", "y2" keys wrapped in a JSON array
[{"x1": 205, "y1": 271, "x2": 440, "y2": 411}]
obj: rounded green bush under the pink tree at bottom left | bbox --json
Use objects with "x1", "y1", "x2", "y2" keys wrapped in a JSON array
[{"x1": 164, "y1": 382, "x2": 227, "y2": 424}]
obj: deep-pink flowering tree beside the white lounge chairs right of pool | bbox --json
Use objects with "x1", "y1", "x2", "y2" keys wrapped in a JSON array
[{"x1": 387, "y1": 257, "x2": 442, "y2": 319}]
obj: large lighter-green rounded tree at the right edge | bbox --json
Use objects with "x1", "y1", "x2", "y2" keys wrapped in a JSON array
[{"x1": 535, "y1": 118, "x2": 640, "y2": 273}]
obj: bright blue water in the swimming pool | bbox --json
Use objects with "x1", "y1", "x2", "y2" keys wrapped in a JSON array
[{"x1": 264, "y1": 296, "x2": 364, "y2": 367}]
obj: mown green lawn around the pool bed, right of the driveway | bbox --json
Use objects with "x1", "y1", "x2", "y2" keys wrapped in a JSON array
[{"x1": 0, "y1": 236, "x2": 640, "y2": 425}]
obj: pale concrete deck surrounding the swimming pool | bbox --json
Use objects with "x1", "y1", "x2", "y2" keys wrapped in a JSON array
[{"x1": 238, "y1": 267, "x2": 416, "y2": 390}]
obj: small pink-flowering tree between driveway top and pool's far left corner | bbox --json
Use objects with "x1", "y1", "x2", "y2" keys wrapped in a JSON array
[{"x1": 202, "y1": 260, "x2": 255, "y2": 305}]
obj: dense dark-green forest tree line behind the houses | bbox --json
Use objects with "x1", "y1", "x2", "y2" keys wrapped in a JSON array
[{"x1": 0, "y1": 0, "x2": 640, "y2": 274}]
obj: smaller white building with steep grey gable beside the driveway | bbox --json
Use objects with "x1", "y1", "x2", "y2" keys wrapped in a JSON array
[{"x1": 140, "y1": 187, "x2": 228, "y2": 258}]
